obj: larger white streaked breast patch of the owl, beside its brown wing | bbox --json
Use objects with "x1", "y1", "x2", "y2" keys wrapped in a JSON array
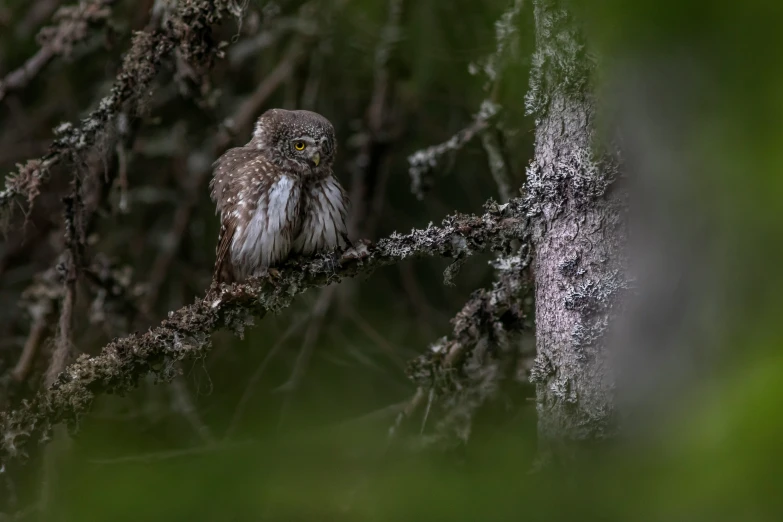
[{"x1": 231, "y1": 175, "x2": 301, "y2": 277}]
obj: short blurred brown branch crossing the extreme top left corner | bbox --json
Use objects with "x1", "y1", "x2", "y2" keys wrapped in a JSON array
[{"x1": 0, "y1": 0, "x2": 115, "y2": 100}]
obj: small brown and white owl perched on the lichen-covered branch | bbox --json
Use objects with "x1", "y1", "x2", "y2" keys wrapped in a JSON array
[{"x1": 210, "y1": 109, "x2": 348, "y2": 283}]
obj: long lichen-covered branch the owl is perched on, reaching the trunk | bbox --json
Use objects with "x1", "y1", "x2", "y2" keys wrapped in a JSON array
[{"x1": 0, "y1": 199, "x2": 527, "y2": 462}]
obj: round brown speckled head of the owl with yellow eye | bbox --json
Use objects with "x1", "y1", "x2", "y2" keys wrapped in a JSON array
[{"x1": 253, "y1": 109, "x2": 337, "y2": 172}]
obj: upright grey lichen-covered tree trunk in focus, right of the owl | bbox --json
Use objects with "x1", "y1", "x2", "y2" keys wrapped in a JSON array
[{"x1": 526, "y1": 0, "x2": 625, "y2": 448}]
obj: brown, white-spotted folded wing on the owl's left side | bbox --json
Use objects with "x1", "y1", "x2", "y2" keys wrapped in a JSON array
[{"x1": 209, "y1": 147, "x2": 257, "y2": 283}]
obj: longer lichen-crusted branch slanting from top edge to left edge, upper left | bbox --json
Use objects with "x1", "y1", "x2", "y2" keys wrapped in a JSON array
[{"x1": 0, "y1": 0, "x2": 233, "y2": 220}]
